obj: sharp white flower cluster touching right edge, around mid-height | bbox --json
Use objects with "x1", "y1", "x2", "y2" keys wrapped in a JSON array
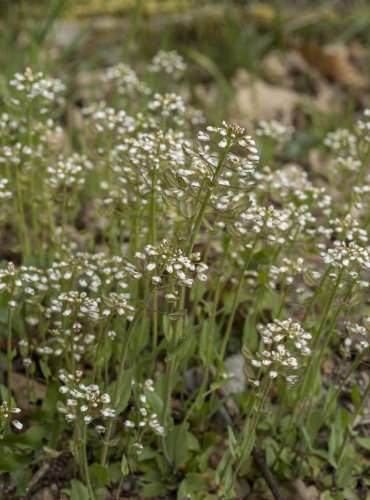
[{"x1": 321, "y1": 240, "x2": 370, "y2": 270}]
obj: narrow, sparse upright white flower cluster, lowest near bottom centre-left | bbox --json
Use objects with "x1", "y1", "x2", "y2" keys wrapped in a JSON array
[{"x1": 123, "y1": 379, "x2": 165, "y2": 454}]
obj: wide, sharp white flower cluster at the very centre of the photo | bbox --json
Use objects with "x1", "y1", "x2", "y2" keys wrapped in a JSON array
[{"x1": 135, "y1": 240, "x2": 208, "y2": 287}]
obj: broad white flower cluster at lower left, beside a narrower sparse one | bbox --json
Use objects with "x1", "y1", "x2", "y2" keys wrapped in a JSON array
[{"x1": 58, "y1": 370, "x2": 116, "y2": 433}]
